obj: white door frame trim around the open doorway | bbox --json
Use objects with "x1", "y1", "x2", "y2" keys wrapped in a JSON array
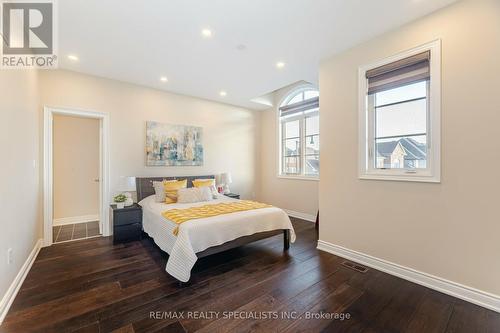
[{"x1": 43, "y1": 106, "x2": 111, "y2": 246}]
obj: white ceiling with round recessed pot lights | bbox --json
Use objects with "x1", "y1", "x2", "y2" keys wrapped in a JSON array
[{"x1": 58, "y1": 0, "x2": 455, "y2": 109}]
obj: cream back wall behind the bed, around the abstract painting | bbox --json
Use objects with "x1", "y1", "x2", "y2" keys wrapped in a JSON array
[{"x1": 40, "y1": 70, "x2": 259, "y2": 198}]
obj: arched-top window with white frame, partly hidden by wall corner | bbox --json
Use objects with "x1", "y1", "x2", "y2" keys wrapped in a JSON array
[{"x1": 279, "y1": 89, "x2": 319, "y2": 178}]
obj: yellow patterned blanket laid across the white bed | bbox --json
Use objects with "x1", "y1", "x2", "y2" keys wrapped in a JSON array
[{"x1": 162, "y1": 200, "x2": 272, "y2": 236}]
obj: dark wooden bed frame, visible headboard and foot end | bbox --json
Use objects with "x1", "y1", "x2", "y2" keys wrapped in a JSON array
[{"x1": 136, "y1": 175, "x2": 290, "y2": 258}]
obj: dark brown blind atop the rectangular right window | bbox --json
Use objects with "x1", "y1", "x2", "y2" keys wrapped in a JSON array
[{"x1": 366, "y1": 51, "x2": 431, "y2": 94}]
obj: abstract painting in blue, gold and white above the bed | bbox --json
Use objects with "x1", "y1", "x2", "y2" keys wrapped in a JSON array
[{"x1": 146, "y1": 121, "x2": 203, "y2": 166}]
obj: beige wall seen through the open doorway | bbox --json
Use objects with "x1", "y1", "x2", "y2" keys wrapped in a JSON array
[{"x1": 53, "y1": 115, "x2": 100, "y2": 219}]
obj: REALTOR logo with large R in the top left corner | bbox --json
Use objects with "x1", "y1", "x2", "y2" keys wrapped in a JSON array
[{"x1": 1, "y1": 0, "x2": 57, "y2": 69}]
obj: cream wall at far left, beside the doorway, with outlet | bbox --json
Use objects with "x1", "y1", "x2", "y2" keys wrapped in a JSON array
[{"x1": 0, "y1": 70, "x2": 41, "y2": 308}]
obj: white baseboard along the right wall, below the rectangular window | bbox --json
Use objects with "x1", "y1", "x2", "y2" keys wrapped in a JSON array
[{"x1": 318, "y1": 240, "x2": 500, "y2": 312}]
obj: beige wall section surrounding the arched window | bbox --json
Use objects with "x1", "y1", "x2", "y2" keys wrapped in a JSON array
[{"x1": 258, "y1": 82, "x2": 322, "y2": 218}]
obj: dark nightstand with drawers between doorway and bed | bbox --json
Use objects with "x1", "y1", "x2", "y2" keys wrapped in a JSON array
[{"x1": 111, "y1": 203, "x2": 142, "y2": 243}]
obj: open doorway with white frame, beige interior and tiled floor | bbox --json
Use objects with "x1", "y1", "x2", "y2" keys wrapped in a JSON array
[{"x1": 43, "y1": 107, "x2": 110, "y2": 246}]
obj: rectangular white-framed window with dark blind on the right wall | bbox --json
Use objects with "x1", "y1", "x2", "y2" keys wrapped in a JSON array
[{"x1": 359, "y1": 41, "x2": 440, "y2": 182}]
